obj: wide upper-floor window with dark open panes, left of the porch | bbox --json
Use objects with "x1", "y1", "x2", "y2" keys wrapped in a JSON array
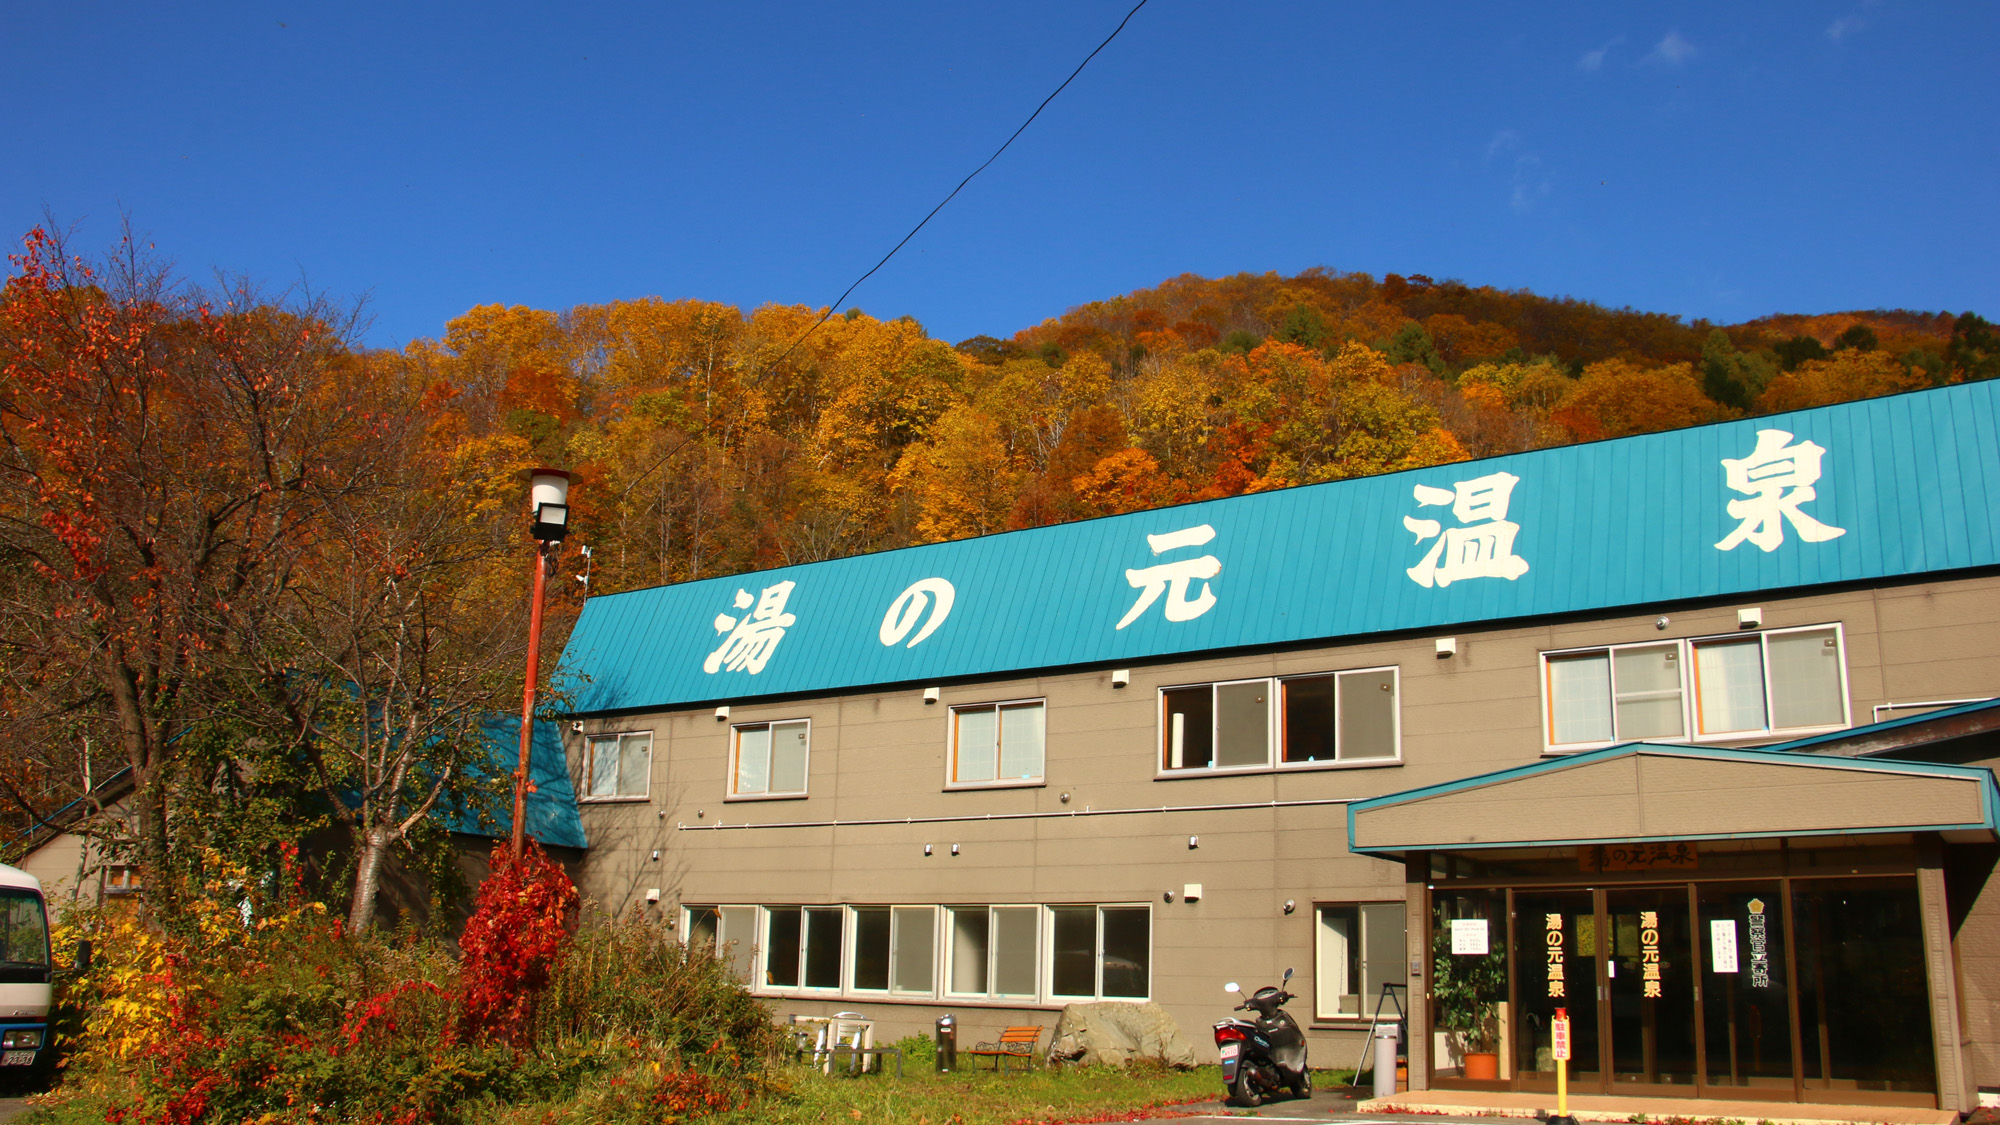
[{"x1": 1160, "y1": 669, "x2": 1402, "y2": 773}]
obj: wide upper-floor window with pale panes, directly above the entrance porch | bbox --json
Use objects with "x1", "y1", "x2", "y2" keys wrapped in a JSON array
[{"x1": 1542, "y1": 625, "x2": 1848, "y2": 749}]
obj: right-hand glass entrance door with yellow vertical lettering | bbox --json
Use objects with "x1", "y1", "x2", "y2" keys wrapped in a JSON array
[{"x1": 1602, "y1": 883, "x2": 1696, "y2": 1095}]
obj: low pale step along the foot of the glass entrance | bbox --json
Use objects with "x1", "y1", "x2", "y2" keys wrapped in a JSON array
[{"x1": 1354, "y1": 1089, "x2": 1958, "y2": 1125}]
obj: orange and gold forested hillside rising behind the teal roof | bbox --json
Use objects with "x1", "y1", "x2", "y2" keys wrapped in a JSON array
[{"x1": 406, "y1": 268, "x2": 2000, "y2": 593}]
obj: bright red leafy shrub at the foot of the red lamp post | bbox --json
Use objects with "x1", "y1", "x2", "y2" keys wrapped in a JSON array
[{"x1": 458, "y1": 841, "x2": 578, "y2": 1047}]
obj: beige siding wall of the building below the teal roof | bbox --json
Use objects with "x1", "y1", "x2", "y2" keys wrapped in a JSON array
[{"x1": 570, "y1": 577, "x2": 2000, "y2": 1067}]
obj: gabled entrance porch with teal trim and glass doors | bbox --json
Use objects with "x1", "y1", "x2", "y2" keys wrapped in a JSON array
[{"x1": 1350, "y1": 745, "x2": 2000, "y2": 1117}]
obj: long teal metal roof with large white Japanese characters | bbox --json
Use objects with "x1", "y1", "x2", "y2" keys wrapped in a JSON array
[{"x1": 562, "y1": 382, "x2": 2000, "y2": 713}]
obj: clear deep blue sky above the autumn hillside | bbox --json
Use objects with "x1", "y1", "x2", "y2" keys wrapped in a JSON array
[{"x1": 0, "y1": 0, "x2": 2000, "y2": 346}]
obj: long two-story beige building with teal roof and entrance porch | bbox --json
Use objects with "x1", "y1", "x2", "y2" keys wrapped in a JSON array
[{"x1": 564, "y1": 384, "x2": 2000, "y2": 1109}]
